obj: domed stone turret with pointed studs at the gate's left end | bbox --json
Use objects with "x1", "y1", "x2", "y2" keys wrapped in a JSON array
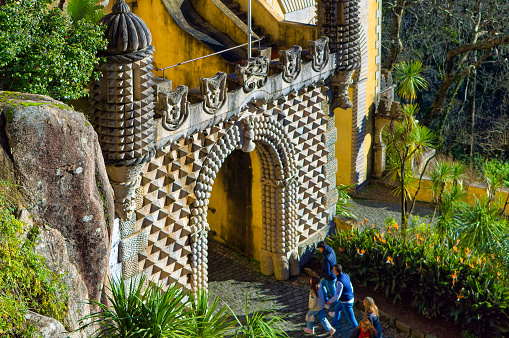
[{"x1": 90, "y1": 0, "x2": 155, "y2": 278}]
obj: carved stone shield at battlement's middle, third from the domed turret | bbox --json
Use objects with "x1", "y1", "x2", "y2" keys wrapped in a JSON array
[{"x1": 235, "y1": 56, "x2": 269, "y2": 92}]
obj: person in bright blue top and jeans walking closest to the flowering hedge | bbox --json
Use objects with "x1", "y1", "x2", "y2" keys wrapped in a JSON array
[{"x1": 326, "y1": 264, "x2": 359, "y2": 329}]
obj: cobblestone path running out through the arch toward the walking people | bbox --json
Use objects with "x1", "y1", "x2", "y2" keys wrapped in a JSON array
[{"x1": 208, "y1": 241, "x2": 403, "y2": 338}]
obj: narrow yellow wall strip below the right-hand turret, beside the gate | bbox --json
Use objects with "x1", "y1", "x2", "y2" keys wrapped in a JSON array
[{"x1": 334, "y1": 87, "x2": 353, "y2": 185}]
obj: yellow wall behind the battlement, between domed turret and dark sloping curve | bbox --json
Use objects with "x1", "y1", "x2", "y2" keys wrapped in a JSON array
[{"x1": 106, "y1": 0, "x2": 234, "y2": 88}]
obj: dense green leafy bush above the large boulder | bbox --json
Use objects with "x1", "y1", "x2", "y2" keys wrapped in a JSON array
[{"x1": 0, "y1": 0, "x2": 106, "y2": 101}]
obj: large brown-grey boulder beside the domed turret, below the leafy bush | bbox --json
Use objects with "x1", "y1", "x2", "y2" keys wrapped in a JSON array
[{"x1": 0, "y1": 92, "x2": 114, "y2": 306}]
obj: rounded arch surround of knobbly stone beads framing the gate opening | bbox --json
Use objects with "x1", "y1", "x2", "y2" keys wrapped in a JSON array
[{"x1": 190, "y1": 115, "x2": 299, "y2": 289}]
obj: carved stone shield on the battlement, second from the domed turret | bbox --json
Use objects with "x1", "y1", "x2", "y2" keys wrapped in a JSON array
[{"x1": 200, "y1": 72, "x2": 227, "y2": 114}]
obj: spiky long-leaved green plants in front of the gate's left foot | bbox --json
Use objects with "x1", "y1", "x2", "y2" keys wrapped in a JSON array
[{"x1": 80, "y1": 275, "x2": 287, "y2": 338}]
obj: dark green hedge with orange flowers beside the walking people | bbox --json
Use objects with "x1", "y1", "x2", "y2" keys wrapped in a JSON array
[{"x1": 329, "y1": 222, "x2": 509, "y2": 337}]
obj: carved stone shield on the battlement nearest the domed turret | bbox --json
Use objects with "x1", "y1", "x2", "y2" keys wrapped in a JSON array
[{"x1": 156, "y1": 85, "x2": 189, "y2": 131}]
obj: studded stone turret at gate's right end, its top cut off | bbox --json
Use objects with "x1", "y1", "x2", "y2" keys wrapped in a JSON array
[{"x1": 317, "y1": 0, "x2": 361, "y2": 109}]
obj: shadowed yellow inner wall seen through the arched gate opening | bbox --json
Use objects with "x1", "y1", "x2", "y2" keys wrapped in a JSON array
[{"x1": 207, "y1": 151, "x2": 262, "y2": 261}]
